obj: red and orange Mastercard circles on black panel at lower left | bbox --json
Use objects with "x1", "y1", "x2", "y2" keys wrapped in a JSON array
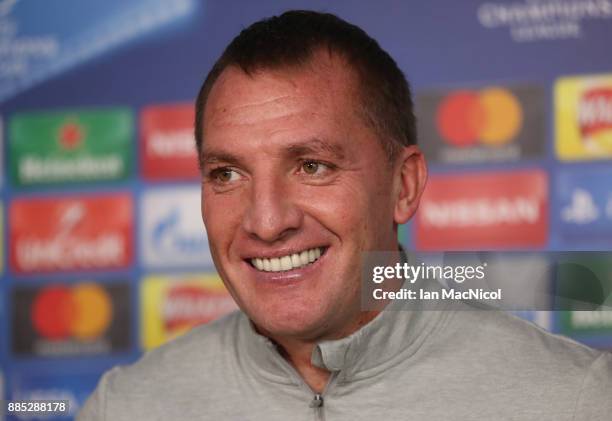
[{"x1": 31, "y1": 282, "x2": 113, "y2": 342}]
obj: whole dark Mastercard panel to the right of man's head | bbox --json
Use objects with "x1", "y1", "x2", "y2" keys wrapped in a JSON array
[{"x1": 417, "y1": 86, "x2": 545, "y2": 163}]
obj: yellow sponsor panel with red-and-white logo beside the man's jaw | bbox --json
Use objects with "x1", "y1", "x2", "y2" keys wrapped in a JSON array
[{"x1": 140, "y1": 274, "x2": 237, "y2": 349}]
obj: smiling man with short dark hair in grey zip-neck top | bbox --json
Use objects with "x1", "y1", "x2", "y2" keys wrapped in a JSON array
[{"x1": 79, "y1": 12, "x2": 612, "y2": 420}]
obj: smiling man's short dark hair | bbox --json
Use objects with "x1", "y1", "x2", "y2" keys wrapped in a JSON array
[{"x1": 195, "y1": 10, "x2": 416, "y2": 159}]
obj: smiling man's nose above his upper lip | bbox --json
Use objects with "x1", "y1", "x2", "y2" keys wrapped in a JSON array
[{"x1": 242, "y1": 176, "x2": 303, "y2": 243}]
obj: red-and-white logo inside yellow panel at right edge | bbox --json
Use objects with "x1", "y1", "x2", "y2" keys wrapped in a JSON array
[{"x1": 578, "y1": 87, "x2": 612, "y2": 138}]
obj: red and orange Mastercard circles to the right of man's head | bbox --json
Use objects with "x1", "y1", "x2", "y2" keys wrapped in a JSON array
[{"x1": 436, "y1": 87, "x2": 523, "y2": 148}]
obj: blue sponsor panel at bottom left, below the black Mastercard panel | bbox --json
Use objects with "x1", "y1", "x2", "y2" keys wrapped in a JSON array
[{"x1": 9, "y1": 371, "x2": 100, "y2": 420}]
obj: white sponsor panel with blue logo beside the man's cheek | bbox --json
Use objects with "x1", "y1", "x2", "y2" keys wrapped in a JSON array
[{"x1": 140, "y1": 186, "x2": 213, "y2": 267}]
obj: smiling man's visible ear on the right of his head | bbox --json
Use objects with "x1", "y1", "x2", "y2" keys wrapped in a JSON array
[{"x1": 393, "y1": 145, "x2": 427, "y2": 224}]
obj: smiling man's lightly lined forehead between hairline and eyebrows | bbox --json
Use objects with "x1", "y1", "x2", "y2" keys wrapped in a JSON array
[{"x1": 204, "y1": 52, "x2": 358, "y2": 131}]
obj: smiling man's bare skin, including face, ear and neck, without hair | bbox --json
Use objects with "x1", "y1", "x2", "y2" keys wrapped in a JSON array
[{"x1": 200, "y1": 41, "x2": 426, "y2": 390}]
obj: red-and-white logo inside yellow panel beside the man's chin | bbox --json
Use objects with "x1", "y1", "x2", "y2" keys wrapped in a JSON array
[{"x1": 162, "y1": 285, "x2": 236, "y2": 332}]
